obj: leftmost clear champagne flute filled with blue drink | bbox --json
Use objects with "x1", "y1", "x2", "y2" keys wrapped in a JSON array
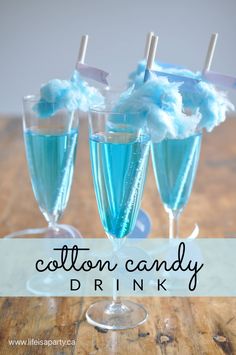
[{"x1": 23, "y1": 96, "x2": 79, "y2": 238}]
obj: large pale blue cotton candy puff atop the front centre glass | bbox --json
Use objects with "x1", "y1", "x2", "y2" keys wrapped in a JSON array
[{"x1": 112, "y1": 74, "x2": 200, "y2": 141}]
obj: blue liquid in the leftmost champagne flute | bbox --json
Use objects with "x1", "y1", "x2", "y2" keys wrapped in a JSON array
[{"x1": 24, "y1": 130, "x2": 78, "y2": 222}]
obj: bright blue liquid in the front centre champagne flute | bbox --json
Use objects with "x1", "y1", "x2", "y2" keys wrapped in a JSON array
[{"x1": 90, "y1": 133, "x2": 150, "y2": 238}]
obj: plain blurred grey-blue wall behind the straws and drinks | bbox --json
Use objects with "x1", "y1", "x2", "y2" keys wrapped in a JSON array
[{"x1": 0, "y1": 0, "x2": 236, "y2": 116}]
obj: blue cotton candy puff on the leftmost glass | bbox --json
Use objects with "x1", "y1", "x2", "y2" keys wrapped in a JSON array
[{"x1": 34, "y1": 71, "x2": 104, "y2": 118}]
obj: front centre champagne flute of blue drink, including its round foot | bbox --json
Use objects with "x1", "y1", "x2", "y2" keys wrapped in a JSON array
[{"x1": 86, "y1": 92, "x2": 150, "y2": 330}]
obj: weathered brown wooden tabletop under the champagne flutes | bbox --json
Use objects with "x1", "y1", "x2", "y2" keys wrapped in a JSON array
[{"x1": 0, "y1": 117, "x2": 236, "y2": 355}]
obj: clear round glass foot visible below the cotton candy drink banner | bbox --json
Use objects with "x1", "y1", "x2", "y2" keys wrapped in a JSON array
[{"x1": 86, "y1": 301, "x2": 148, "y2": 330}]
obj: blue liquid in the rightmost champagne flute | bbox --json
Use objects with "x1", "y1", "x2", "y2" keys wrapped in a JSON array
[{"x1": 152, "y1": 134, "x2": 202, "y2": 211}]
